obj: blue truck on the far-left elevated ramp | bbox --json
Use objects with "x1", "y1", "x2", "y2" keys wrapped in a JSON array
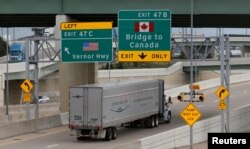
[{"x1": 8, "y1": 43, "x2": 25, "y2": 62}]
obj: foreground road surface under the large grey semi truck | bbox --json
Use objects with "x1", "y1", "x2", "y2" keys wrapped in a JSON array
[{"x1": 0, "y1": 82, "x2": 250, "y2": 149}]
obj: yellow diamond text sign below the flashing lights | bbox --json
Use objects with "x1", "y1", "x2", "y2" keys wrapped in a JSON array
[{"x1": 180, "y1": 103, "x2": 201, "y2": 126}]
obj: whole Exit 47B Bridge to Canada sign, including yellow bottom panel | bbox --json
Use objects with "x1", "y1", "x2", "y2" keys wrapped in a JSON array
[{"x1": 118, "y1": 10, "x2": 171, "y2": 62}]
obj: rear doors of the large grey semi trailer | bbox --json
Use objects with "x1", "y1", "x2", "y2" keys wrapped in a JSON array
[{"x1": 70, "y1": 87, "x2": 102, "y2": 128}]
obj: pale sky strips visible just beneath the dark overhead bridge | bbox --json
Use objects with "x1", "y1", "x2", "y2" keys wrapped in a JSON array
[{"x1": 0, "y1": 27, "x2": 250, "y2": 40}]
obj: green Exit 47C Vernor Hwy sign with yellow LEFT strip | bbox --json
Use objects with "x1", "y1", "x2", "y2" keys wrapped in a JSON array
[{"x1": 61, "y1": 22, "x2": 113, "y2": 63}]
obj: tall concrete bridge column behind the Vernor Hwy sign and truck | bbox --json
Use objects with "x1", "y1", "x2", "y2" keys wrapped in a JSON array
[{"x1": 55, "y1": 15, "x2": 98, "y2": 112}]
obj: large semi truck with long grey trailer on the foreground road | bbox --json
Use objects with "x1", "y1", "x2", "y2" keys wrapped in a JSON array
[{"x1": 69, "y1": 80, "x2": 171, "y2": 141}]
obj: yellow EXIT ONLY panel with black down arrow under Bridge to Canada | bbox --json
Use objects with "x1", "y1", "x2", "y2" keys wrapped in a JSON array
[{"x1": 118, "y1": 51, "x2": 171, "y2": 62}]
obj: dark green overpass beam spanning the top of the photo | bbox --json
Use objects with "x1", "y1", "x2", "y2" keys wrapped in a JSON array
[{"x1": 0, "y1": 0, "x2": 250, "y2": 28}]
